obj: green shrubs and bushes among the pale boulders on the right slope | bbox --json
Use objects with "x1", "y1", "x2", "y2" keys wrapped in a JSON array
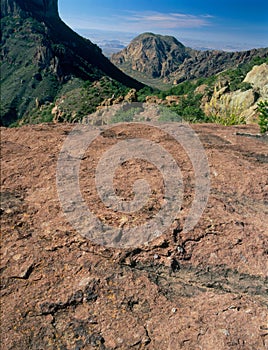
[{"x1": 138, "y1": 57, "x2": 268, "y2": 125}]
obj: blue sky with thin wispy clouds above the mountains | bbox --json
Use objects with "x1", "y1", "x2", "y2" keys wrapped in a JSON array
[{"x1": 59, "y1": 0, "x2": 268, "y2": 50}]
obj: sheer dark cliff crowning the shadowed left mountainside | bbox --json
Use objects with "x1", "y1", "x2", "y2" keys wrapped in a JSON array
[{"x1": 1, "y1": 0, "x2": 59, "y2": 19}]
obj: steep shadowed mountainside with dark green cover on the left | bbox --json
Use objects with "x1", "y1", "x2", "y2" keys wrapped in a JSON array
[{"x1": 1, "y1": 0, "x2": 143, "y2": 125}]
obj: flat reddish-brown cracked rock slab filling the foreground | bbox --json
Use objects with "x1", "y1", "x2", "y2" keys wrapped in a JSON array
[{"x1": 1, "y1": 124, "x2": 268, "y2": 350}]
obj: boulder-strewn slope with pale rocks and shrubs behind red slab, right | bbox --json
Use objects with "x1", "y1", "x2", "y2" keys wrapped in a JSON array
[{"x1": 101, "y1": 58, "x2": 268, "y2": 125}]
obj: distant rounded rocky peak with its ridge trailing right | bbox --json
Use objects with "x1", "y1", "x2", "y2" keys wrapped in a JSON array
[{"x1": 111, "y1": 33, "x2": 268, "y2": 83}]
